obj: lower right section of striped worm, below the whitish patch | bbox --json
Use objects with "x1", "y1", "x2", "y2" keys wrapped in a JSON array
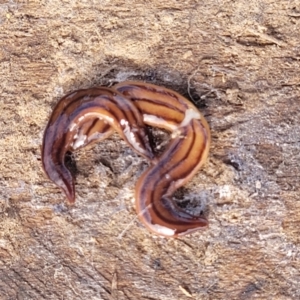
[{"x1": 135, "y1": 120, "x2": 208, "y2": 237}]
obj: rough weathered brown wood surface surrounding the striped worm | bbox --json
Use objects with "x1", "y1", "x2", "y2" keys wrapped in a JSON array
[{"x1": 0, "y1": 0, "x2": 300, "y2": 300}]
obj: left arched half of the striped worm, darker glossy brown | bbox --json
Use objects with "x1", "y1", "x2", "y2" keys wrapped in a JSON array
[{"x1": 42, "y1": 88, "x2": 154, "y2": 203}]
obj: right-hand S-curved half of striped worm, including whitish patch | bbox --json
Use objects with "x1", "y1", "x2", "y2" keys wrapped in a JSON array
[{"x1": 114, "y1": 82, "x2": 211, "y2": 237}]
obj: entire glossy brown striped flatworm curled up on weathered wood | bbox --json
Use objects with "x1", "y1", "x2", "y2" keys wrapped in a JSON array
[{"x1": 42, "y1": 81, "x2": 210, "y2": 237}]
